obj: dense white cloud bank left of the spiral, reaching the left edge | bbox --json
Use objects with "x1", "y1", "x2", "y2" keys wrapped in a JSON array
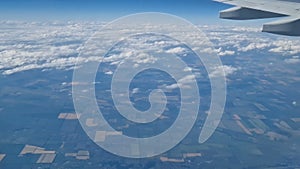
[{"x1": 0, "y1": 22, "x2": 98, "y2": 75}]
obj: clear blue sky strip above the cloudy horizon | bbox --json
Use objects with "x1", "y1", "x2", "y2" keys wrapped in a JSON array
[{"x1": 0, "y1": 0, "x2": 231, "y2": 22}]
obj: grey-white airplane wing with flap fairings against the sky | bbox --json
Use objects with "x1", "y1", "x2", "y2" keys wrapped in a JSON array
[{"x1": 214, "y1": 0, "x2": 300, "y2": 36}]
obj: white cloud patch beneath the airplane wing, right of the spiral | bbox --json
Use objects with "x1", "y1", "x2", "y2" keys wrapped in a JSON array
[{"x1": 201, "y1": 25, "x2": 300, "y2": 55}]
